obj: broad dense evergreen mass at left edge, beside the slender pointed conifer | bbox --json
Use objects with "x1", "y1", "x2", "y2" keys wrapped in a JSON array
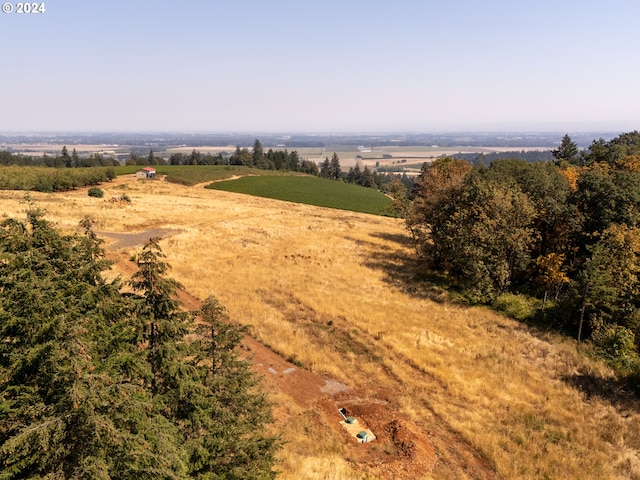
[{"x1": 0, "y1": 211, "x2": 186, "y2": 479}]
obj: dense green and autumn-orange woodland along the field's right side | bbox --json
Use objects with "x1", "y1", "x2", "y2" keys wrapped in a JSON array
[{"x1": 395, "y1": 131, "x2": 640, "y2": 374}]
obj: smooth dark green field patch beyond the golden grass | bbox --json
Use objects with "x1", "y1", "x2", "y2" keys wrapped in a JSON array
[{"x1": 206, "y1": 175, "x2": 391, "y2": 215}]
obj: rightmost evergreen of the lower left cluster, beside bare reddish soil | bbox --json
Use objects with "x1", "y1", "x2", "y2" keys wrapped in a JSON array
[{"x1": 186, "y1": 297, "x2": 280, "y2": 480}]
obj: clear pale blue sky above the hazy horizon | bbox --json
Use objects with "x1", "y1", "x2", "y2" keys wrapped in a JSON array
[{"x1": 0, "y1": 0, "x2": 640, "y2": 132}]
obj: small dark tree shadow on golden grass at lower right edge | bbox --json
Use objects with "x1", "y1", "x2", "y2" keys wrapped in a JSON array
[{"x1": 562, "y1": 373, "x2": 640, "y2": 412}]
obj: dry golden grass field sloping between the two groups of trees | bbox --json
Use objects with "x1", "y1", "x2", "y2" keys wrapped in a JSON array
[{"x1": 0, "y1": 177, "x2": 640, "y2": 479}]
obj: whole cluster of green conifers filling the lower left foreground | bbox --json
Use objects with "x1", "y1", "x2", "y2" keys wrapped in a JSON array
[{"x1": 0, "y1": 212, "x2": 280, "y2": 480}]
